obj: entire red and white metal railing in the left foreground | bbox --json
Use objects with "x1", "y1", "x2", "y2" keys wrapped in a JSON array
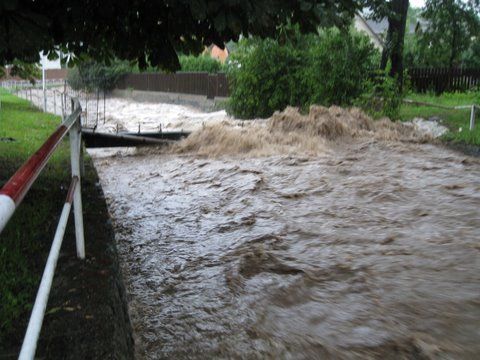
[{"x1": 0, "y1": 99, "x2": 85, "y2": 360}]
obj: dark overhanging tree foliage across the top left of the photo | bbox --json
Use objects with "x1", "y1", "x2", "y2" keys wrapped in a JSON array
[{"x1": 0, "y1": 0, "x2": 364, "y2": 70}]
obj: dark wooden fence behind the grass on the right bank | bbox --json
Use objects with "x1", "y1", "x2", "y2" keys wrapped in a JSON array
[{"x1": 408, "y1": 68, "x2": 480, "y2": 94}]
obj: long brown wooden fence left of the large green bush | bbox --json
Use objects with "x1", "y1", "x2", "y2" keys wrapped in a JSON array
[{"x1": 117, "y1": 72, "x2": 229, "y2": 99}]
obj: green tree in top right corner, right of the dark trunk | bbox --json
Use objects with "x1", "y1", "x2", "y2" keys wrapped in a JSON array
[{"x1": 419, "y1": 0, "x2": 480, "y2": 69}]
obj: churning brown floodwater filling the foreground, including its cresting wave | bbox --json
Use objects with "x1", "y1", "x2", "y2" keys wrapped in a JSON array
[{"x1": 90, "y1": 102, "x2": 480, "y2": 359}]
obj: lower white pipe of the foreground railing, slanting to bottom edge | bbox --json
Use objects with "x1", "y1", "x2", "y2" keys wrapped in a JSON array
[{"x1": 18, "y1": 202, "x2": 72, "y2": 360}]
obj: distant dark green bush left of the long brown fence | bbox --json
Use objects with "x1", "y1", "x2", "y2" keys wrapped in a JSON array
[{"x1": 67, "y1": 61, "x2": 131, "y2": 91}]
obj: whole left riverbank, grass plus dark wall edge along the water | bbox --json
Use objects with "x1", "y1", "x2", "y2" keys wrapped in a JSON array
[{"x1": 0, "y1": 90, "x2": 133, "y2": 359}]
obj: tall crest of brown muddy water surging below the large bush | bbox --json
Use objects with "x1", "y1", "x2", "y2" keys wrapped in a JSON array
[{"x1": 172, "y1": 106, "x2": 432, "y2": 157}]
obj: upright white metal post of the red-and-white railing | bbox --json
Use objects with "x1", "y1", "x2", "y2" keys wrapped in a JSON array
[{"x1": 70, "y1": 99, "x2": 85, "y2": 259}]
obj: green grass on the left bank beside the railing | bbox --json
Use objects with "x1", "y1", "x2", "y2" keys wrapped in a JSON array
[{"x1": 0, "y1": 89, "x2": 70, "y2": 349}]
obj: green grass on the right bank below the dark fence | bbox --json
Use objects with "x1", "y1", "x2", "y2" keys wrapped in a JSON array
[{"x1": 400, "y1": 91, "x2": 480, "y2": 146}]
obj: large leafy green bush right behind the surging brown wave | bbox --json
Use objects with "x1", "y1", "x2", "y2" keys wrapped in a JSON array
[{"x1": 227, "y1": 29, "x2": 378, "y2": 118}]
